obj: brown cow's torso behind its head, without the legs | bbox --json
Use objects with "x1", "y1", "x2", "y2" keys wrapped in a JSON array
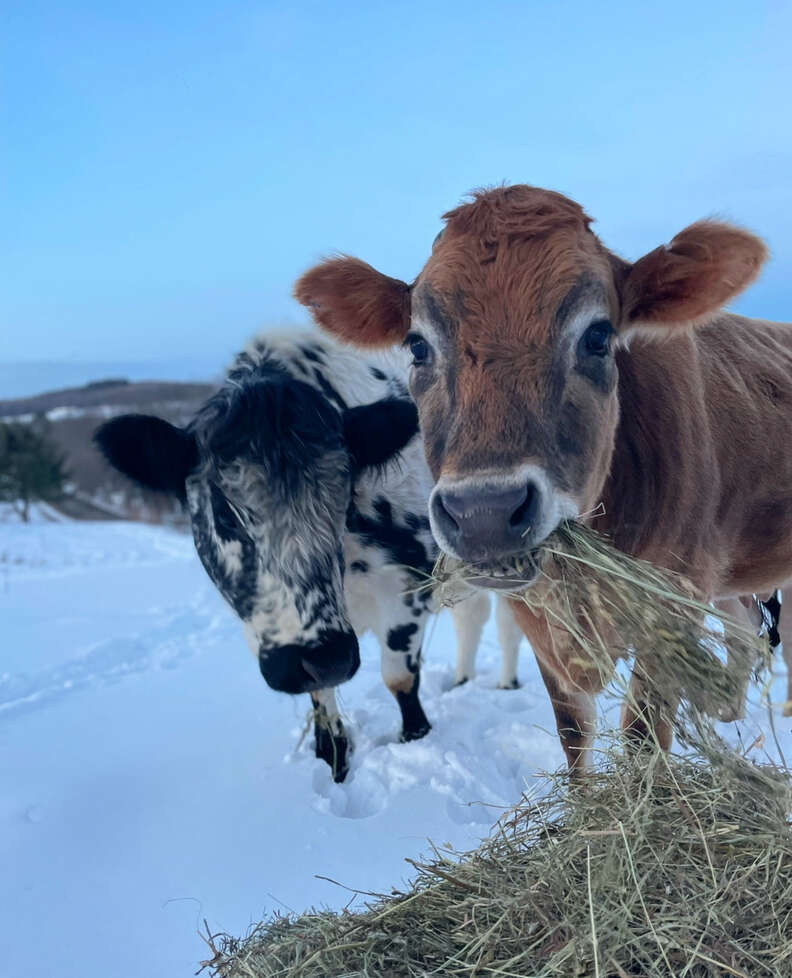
[{"x1": 600, "y1": 315, "x2": 792, "y2": 598}]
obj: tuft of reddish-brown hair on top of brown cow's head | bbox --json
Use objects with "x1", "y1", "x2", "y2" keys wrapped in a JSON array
[{"x1": 443, "y1": 184, "x2": 591, "y2": 238}]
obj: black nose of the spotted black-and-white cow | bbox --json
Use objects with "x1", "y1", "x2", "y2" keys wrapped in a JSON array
[{"x1": 259, "y1": 631, "x2": 360, "y2": 693}]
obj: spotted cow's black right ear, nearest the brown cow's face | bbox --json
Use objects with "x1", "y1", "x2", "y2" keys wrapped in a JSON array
[{"x1": 344, "y1": 398, "x2": 418, "y2": 470}]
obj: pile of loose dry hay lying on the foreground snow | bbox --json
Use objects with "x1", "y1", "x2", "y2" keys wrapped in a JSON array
[{"x1": 205, "y1": 745, "x2": 792, "y2": 978}]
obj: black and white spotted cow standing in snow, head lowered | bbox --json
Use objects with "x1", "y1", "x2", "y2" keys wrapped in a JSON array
[{"x1": 96, "y1": 332, "x2": 521, "y2": 781}]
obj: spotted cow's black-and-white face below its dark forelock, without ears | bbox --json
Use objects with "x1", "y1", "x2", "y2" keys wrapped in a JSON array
[{"x1": 187, "y1": 428, "x2": 359, "y2": 693}]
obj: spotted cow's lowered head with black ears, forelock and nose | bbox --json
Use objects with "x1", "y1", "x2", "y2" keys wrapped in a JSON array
[{"x1": 96, "y1": 366, "x2": 417, "y2": 693}]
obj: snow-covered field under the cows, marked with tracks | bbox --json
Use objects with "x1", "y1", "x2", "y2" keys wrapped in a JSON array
[{"x1": 0, "y1": 521, "x2": 792, "y2": 978}]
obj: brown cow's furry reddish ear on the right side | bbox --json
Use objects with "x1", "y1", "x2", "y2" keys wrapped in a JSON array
[{"x1": 620, "y1": 221, "x2": 767, "y2": 335}]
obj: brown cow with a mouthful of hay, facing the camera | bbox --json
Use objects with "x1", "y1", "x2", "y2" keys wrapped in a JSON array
[{"x1": 295, "y1": 186, "x2": 792, "y2": 768}]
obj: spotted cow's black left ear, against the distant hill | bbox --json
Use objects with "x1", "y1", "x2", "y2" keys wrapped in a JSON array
[{"x1": 94, "y1": 414, "x2": 198, "y2": 500}]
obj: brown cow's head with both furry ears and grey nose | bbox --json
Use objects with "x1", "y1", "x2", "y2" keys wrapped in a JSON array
[{"x1": 295, "y1": 186, "x2": 766, "y2": 580}]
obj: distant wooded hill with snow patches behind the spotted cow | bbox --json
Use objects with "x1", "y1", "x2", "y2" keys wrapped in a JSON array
[{"x1": 0, "y1": 377, "x2": 216, "y2": 524}]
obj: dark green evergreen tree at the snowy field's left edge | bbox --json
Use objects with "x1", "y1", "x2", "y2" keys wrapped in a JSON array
[{"x1": 0, "y1": 422, "x2": 67, "y2": 523}]
